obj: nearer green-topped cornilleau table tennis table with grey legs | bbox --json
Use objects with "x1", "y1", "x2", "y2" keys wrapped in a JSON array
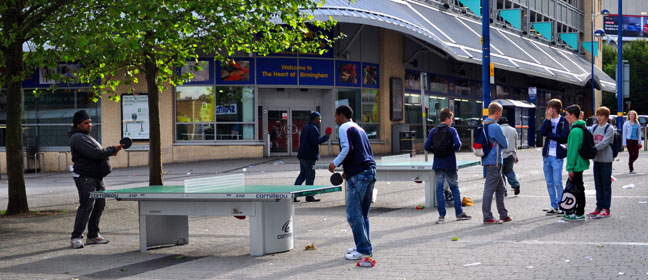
[{"x1": 90, "y1": 181, "x2": 341, "y2": 256}]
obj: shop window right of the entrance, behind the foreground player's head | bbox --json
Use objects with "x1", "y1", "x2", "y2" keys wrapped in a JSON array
[{"x1": 335, "y1": 88, "x2": 380, "y2": 139}]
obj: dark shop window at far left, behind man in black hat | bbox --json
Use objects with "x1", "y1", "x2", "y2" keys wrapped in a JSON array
[{"x1": 22, "y1": 89, "x2": 101, "y2": 149}]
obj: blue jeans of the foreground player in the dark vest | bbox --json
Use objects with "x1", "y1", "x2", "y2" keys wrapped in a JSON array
[{"x1": 347, "y1": 168, "x2": 376, "y2": 255}]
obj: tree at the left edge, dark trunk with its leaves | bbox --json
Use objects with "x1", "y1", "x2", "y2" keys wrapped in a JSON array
[{"x1": 0, "y1": 0, "x2": 75, "y2": 215}]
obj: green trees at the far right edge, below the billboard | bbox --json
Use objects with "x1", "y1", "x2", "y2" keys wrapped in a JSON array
[{"x1": 603, "y1": 40, "x2": 648, "y2": 113}]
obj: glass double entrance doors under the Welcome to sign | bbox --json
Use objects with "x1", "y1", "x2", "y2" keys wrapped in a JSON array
[{"x1": 265, "y1": 109, "x2": 311, "y2": 156}]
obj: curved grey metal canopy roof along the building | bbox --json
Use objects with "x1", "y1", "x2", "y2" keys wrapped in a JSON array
[{"x1": 313, "y1": 0, "x2": 616, "y2": 92}]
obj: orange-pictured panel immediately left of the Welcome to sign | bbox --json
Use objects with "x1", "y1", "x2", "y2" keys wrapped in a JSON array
[{"x1": 216, "y1": 57, "x2": 254, "y2": 85}]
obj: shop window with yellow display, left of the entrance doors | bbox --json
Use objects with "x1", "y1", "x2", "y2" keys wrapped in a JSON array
[{"x1": 176, "y1": 86, "x2": 255, "y2": 141}]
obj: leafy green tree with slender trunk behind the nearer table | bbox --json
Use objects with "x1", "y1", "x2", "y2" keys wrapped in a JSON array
[{"x1": 55, "y1": 0, "x2": 335, "y2": 185}]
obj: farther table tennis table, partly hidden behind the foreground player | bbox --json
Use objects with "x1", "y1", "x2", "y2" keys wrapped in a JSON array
[{"x1": 317, "y1": 154, "x2": 480, "y2": 208}]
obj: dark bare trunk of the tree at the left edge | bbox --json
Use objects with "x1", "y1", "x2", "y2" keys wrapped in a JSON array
[{"x1": 3, "y1": 40, "x2": 29, "y2": 215}]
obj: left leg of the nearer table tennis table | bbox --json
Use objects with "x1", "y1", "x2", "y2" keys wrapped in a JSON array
[{"x1": 138, "y1": 201, "x2": 189, "y2": 252}]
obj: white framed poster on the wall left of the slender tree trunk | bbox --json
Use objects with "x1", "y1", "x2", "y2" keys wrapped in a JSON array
[{"x1": 121, "y1": 94, "x2": 149, "y2": 140}]
